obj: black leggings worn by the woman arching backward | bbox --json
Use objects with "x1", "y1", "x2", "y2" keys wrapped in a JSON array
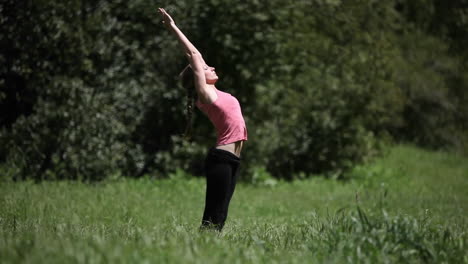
[{"x1": 201, "y1": 148, "x2": 240, "y2": 231}]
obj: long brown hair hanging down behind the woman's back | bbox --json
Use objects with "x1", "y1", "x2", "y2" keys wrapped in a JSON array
[{"x1": 179, "y1": 64, "x2": 197, "y2": 140}]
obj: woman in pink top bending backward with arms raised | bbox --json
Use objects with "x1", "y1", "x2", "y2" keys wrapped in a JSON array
[{"x1": 159, "y1": 8, "x2": 247, "y2": 231}]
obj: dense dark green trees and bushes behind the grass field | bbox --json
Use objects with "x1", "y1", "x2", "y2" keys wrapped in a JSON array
[{"x1": 0, "y1": 0, "x2": 468, "y2": 180}]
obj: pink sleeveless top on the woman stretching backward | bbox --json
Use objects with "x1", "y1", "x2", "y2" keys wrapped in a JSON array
[{"x1": 197, "y1": 89, "x2": 247, "y2": 146}]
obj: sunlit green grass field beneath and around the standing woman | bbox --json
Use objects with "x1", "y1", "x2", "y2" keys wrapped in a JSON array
[{"x1": 0, "y1": 146, "x2": 468, "y2": 263}]
